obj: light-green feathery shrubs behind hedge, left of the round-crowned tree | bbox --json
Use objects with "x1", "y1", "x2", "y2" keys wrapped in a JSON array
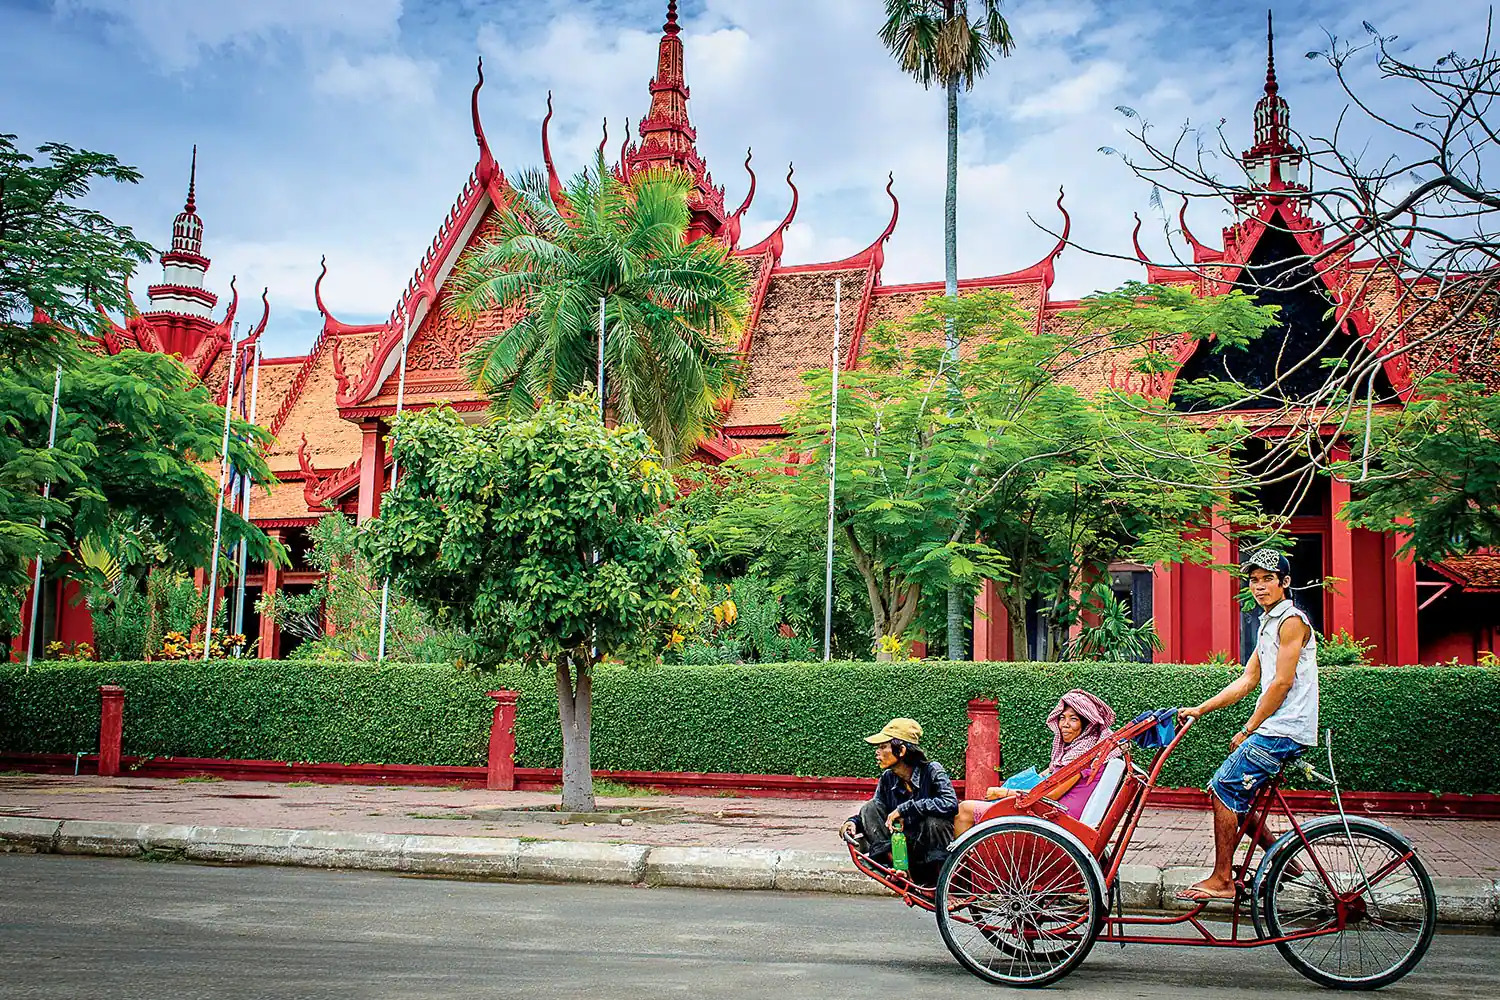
[{"x1": 255, "y1": 514, "x2": 464, "y2": 663}]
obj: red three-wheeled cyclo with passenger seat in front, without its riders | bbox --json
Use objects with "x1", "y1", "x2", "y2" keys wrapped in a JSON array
[{"x1": 845, "y1": 709, "x2": 1437, "y2": 990}]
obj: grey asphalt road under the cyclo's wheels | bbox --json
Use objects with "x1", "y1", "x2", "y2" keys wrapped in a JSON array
[{"x1": 0, "y1": 855, "x2": 1500, "y2": 1000}]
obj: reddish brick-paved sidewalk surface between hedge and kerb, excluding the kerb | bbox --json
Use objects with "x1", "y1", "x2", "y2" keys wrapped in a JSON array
[{"x1": 0, "y1": 774, "x2": 1500, "y2": 880}]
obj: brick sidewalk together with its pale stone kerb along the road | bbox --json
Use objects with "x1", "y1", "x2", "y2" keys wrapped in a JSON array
[{"x1": 0, "y1": 775, "x2": 1500, "y2": 925}]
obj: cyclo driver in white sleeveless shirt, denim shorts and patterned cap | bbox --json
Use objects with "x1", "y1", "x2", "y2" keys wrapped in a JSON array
[{"x1": 1178, "y1": 549, "x2": 1317, "y2": 901}]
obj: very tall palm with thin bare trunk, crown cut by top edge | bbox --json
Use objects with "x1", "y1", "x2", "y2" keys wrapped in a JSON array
[{"x1": 881, "y1": 0, "x2": 1016, "y2": 660}]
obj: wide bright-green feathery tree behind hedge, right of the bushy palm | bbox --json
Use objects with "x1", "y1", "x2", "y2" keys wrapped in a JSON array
[{"x1": 708, "y1": 285, "x2": 1271, "y2": 657}]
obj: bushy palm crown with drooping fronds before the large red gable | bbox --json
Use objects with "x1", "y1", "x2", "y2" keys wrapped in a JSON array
[{"x1": 453, "y1": 157, "x2": 750, "y2": 462}]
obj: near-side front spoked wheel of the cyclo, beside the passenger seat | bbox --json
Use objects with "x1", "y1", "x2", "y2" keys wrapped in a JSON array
[{"x1": 938, "y1": 823, "x2": 1104, "y2": 987}]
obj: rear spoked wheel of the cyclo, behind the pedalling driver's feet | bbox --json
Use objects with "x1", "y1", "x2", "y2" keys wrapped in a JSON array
[{"x1": 1262, "y1": 819, "x2": 1437, "y2": 990}]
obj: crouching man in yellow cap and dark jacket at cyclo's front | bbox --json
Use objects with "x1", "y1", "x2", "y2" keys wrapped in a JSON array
[{"x1": 845, "y1": 718, "x2": 959, "y2": 885}]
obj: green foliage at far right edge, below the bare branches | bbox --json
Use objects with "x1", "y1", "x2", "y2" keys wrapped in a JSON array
[{"x1": 1334, "y1": 373, "x2": 1500, "y2": 561}]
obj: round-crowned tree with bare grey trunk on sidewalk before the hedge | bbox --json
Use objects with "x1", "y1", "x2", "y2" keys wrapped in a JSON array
[{"x1": 362, "y1": 397, "x2": 702, "y2": 810}]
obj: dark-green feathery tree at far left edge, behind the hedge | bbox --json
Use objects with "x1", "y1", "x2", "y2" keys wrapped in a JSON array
[{"x1": 0, "y1": 136, "x2": 273, "y2": 641}]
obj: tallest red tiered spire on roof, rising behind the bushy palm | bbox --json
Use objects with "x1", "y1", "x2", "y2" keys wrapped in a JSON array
[{"x1": 621, "y1": 0, "x2": 725, "y2": 240}]
